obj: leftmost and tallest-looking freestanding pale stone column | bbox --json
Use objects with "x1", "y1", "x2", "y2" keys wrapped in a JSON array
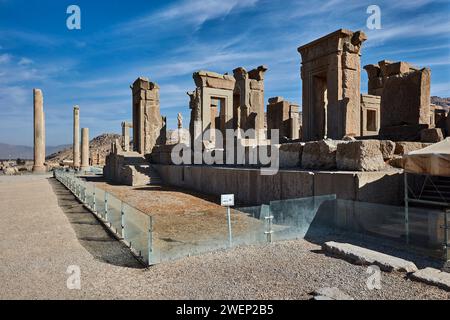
[{"x1": 33, "y1": 89, "x2": 46, "y2": 172}]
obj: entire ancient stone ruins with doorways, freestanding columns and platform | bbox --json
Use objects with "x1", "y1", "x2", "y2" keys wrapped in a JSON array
[{"x1": 30, "y1": 29, "x2": 450, "y2": 208}]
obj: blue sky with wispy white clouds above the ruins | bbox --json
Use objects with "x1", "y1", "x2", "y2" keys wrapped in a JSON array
[{"x1": 0, "y1": 0, "x2": 450, "y2": 145}]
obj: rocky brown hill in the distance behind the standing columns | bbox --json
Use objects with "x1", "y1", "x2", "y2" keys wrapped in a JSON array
[{"x1": 47, "y1": 133, "x2": 121, "y2": 165}]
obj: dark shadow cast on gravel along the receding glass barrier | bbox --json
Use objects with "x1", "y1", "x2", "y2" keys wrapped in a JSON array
[{"x1": 48, "y1": 178, "x2": 143, "y2": 268}]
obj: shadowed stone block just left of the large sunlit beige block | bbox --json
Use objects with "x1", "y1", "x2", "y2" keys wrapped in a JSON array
[{"x1": 302, "y1": 139, "x2": 346, "y2": 170}]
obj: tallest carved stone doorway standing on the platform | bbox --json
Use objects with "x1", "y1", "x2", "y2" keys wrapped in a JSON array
[{"x1": 298, "y1": 29, "x2": 367, "y2": 141}]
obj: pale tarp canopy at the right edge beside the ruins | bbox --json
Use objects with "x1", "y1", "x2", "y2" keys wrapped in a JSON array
[{"x1": 404, "y1": 138, "x2": 450, "y2": 177}]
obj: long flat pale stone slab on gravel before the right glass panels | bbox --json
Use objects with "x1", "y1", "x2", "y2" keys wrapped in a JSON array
[{"x1": 322, "y1": 241, "x2": 418, "y2": 273}]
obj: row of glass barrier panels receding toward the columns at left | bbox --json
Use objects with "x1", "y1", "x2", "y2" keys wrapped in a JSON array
[{"x1": 54, "y1": 170, "x2": 154, "y2": 266}]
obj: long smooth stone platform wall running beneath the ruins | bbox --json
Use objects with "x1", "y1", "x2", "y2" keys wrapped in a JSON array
[{"x1": 153, "y1": 164, "x2": 403, "y2": 205}]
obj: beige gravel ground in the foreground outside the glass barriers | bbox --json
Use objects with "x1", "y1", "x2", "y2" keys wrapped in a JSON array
[{"x1": 0, "y1": 176, "x2": 450, "y2": 299}]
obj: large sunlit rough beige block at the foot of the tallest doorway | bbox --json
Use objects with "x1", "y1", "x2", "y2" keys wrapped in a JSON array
[{"x1": 336, "y1": 140, "x2": 385, "y2": 171}]
